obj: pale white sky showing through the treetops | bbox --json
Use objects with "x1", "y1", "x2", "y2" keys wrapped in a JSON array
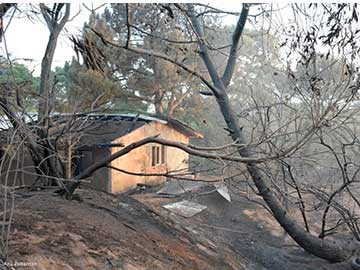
[{"x1": 0, "y1": 1, "x2": 241, "y2": 75}]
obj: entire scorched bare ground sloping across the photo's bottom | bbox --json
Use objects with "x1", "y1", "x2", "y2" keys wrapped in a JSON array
[{"x1": 0, "y1": 182, "x2": 350, "y2": 270}]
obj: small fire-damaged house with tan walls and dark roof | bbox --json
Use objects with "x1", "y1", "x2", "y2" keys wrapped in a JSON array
[{"x1": 0, "y1": 114, "x2": 202, "y2": 193}]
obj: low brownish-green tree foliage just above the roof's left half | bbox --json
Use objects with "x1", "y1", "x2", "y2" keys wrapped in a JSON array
[{"x1": 54, "y1": 59, "x2": 146, "y2": 112}]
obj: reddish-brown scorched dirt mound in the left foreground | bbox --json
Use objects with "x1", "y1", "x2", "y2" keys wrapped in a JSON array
[{"x1": 4, "y1": 191, "x2": 243, "y2": 270}]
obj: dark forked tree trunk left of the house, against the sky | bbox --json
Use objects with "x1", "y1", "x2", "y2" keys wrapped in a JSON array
[{"x1": 0, "y1": 4, "x2": 70, "y2": 186}]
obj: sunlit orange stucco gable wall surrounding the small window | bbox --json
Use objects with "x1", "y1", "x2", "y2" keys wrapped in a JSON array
[{"x1": 110, "y1": 122, "x2": 189, "y2": 193}]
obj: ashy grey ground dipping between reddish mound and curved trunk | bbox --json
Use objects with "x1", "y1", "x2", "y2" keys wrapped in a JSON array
[{"x1": 135, "y1": 191, "x2": 350, "y2": 270}]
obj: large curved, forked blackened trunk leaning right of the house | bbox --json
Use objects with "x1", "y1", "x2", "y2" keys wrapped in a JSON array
[{"x1": 187, "y1": 4, "x2": 349, "y2": 262}]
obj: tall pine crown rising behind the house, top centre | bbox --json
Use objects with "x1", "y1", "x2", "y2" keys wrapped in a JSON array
[{"x1": 84, "y1": 4, "x2": 207, "y2": 118}]
